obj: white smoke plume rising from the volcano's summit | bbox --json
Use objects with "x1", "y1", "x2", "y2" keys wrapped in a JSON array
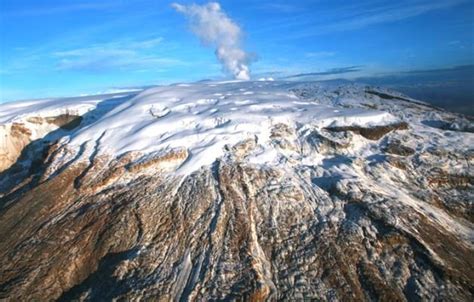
[{"x1": 172, "y1": 2, "x2": 250, "y2": 80}]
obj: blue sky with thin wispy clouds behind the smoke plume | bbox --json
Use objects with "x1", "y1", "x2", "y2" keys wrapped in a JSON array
[{"x1": 0, "y1": 0, "x2": 474, "y2": 102}]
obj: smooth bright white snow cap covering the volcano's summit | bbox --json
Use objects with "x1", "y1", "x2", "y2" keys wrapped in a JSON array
[{"x1": 0, "y1": 81, "x2": 406, "y2": 175}]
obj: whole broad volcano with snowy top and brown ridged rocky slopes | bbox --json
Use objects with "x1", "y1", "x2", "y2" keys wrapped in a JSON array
[{"x1": 0, "y1": 81, "x2": 474, "y2": 301}]
